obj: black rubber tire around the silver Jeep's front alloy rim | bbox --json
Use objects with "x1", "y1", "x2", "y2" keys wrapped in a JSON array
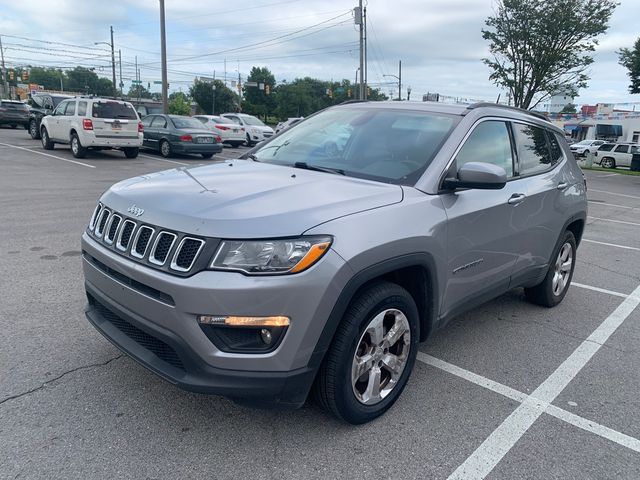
[{"x1": 314, "y1": 282, "x2": 420, "y2": 424}]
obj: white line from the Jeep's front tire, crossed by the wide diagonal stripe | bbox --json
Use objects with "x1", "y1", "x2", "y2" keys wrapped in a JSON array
[{"x1": 417, "y1": 352, "x2": 640, "y2": 452}]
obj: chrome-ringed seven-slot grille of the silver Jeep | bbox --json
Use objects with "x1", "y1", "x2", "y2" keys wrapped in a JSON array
[{"x1": 88, "y1": 204, "x2": 206, "y2": 275}]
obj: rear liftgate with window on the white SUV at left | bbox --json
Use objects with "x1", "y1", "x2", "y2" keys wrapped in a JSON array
[{"x1": 91, "y1": 100, "x2": 138, "y2": 140}]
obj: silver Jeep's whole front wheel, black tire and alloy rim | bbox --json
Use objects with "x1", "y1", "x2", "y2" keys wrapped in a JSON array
[{"x1": 314, "y1": 282, "x2": 420, "y2": 424}]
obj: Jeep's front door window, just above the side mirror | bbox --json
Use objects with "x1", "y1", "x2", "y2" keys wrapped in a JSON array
[{"x1": 456, "y1": 120, "x2": 513, "y2": 178}]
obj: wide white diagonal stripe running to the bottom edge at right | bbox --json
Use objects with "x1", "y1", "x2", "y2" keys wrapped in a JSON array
[{"x1": 449, "y1": 286, "x2": 640, "y2": 480}]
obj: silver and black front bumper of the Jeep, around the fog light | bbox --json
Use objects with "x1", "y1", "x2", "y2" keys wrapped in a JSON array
[{"x1": 82, "y1": 233, "x2": 348, "y2": 407}]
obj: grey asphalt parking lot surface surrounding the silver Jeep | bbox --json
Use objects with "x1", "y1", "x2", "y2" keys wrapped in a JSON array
[{"x1": 0, "y1": 125, "x2": 640, "y2": 479}]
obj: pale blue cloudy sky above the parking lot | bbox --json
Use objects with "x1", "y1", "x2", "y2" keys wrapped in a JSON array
[{"x1": 0, "y1": 0, "x2": 640, "y2": 110}]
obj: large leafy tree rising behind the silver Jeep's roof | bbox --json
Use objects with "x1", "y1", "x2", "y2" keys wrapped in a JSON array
[{"x1": 482, "y1": 0, "x2": 617, "y2": 108}]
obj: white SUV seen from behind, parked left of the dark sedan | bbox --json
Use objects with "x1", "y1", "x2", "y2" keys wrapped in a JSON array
[{"x1": 40, "y1": 97, "x2": 143, "y2": 158}]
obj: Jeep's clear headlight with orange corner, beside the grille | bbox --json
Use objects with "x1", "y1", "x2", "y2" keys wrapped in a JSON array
[{"x1": 211, "y1": 237, "x2": 331, "y2": 275}]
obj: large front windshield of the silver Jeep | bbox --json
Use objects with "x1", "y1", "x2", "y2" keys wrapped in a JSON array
[{"x1": 254, "y1": 106, "x2": 459, "y2": 185}]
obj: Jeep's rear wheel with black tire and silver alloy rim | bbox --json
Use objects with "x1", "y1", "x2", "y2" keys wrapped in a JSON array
[{"x1": 524, "y1": 231, "x2": 577, "y2": 307}]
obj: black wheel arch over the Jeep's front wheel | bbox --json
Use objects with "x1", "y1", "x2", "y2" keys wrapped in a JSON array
[{"x1": 308, "y1": 252, "x2": 440, "y2": 367}]
